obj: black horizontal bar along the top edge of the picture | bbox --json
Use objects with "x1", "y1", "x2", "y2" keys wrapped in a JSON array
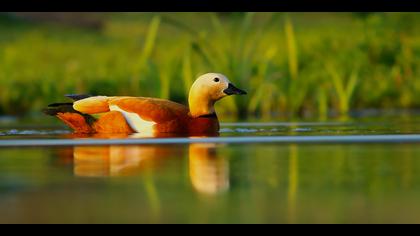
[{"x1": 1, "y1": 0, "x2": 420, "y2": 12}]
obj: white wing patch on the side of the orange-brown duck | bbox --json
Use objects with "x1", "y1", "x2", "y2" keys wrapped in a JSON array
[{"x1": 109, "y1": 105, "x2": 156, "y2": 135}]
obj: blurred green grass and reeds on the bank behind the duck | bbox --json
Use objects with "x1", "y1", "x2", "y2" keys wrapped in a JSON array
[{"x1": 0, "y1": 13, "x2": 420, "y2": 120}]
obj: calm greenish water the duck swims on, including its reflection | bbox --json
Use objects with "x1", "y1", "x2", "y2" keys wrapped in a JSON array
[{"x1": 0, "y1": 116, "x2": 420, "y2": 223}]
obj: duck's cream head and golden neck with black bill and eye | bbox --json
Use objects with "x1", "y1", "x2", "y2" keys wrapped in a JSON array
[{"x1": 188, "y1": 73, "x2": 247, "y2": 117}]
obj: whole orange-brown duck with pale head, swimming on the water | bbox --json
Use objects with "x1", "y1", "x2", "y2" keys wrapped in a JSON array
[{"x1": 43, "y1": 73, "x2": 247, "y2": 137}]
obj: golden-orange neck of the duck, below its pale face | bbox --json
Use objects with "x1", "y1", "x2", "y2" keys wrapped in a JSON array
[{"x1": 188, "y1": 92, "x2": 216, "y2": 118}]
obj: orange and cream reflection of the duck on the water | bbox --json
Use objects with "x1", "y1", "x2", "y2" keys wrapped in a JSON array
[{"x1": 66, "y1": 136, "x2": 229, "y2": 194}]
